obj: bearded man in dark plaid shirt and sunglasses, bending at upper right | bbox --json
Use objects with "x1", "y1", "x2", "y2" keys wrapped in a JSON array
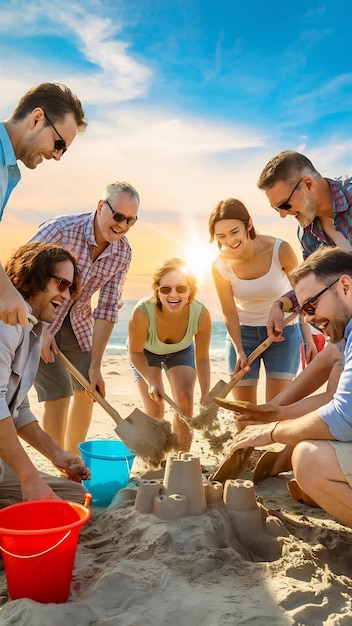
[{"x1": 257, "y1": 150, "x2": 352, "y2": 341}]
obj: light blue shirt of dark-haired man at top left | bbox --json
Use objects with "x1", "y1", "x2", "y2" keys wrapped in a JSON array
[{"x1": 0, "y1": 122, "x2": 21, "y2": 221}]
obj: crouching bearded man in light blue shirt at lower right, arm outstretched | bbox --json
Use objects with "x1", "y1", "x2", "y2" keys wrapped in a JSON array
[{"x1": 231, "y1": 247, "x2": 352, "y2": 527}]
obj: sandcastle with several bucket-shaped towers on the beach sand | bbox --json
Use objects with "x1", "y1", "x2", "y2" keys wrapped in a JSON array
[{"x1": 135, "y1": 452, "x2": 289, "y2": 560}]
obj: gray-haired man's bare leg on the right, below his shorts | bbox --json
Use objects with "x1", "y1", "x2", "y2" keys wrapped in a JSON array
[{"x1": 64, "y1": 390, "x2": 93, "y2": 454}]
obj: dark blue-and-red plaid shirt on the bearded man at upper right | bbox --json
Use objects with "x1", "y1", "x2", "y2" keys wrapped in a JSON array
[{"x1": 285, "y1": 177, "x2": 352, "y2": 310}]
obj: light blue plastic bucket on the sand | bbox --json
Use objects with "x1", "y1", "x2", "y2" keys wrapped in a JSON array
[{"x1": 78, "y1": 439, "x2": 135, "y2": 506}]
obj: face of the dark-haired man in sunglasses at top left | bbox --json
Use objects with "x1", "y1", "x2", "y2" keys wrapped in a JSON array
[{"x1": 16, "y1": 107, "x2": 78, "y2": 169}]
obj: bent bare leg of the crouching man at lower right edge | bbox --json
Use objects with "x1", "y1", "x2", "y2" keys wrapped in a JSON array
[{"x1": 292, "y1": 441, "x2": 352, "y2": 528}]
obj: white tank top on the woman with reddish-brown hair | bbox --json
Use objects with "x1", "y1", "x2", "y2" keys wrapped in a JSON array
[{"x1": 215, "y1": 239, "x2": 297, "y2": 326}]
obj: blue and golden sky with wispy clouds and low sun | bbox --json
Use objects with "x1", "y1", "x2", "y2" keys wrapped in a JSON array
[{"x1": 0, "y1": 0, "x2": 352, "y2": 314}]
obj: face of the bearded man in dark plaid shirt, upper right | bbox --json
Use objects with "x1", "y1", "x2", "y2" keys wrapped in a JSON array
[{"x1": 265, "y1": 176, "x2": 316, "y2": 228}]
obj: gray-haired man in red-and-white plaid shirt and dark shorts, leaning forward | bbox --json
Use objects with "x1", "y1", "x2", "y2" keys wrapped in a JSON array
[{"x1": 31, "y1": 181, "x2": 139, "y2": 453}]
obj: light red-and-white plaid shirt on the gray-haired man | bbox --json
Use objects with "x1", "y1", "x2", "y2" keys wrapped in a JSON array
[{"x1": 31, "y1": 212, "x2": 132, "y2": 352}]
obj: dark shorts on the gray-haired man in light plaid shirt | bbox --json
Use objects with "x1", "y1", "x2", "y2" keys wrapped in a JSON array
[{"x1": 34, "y1": 313, "x2": 92, "y2": 402}]
